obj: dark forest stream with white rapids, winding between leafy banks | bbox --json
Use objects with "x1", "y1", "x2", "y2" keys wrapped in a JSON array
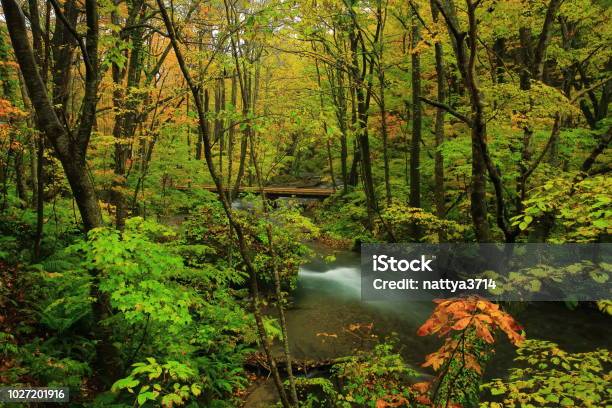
[{"x1": 245, "y1": 244, "x2": 612, "y2": 407}]
